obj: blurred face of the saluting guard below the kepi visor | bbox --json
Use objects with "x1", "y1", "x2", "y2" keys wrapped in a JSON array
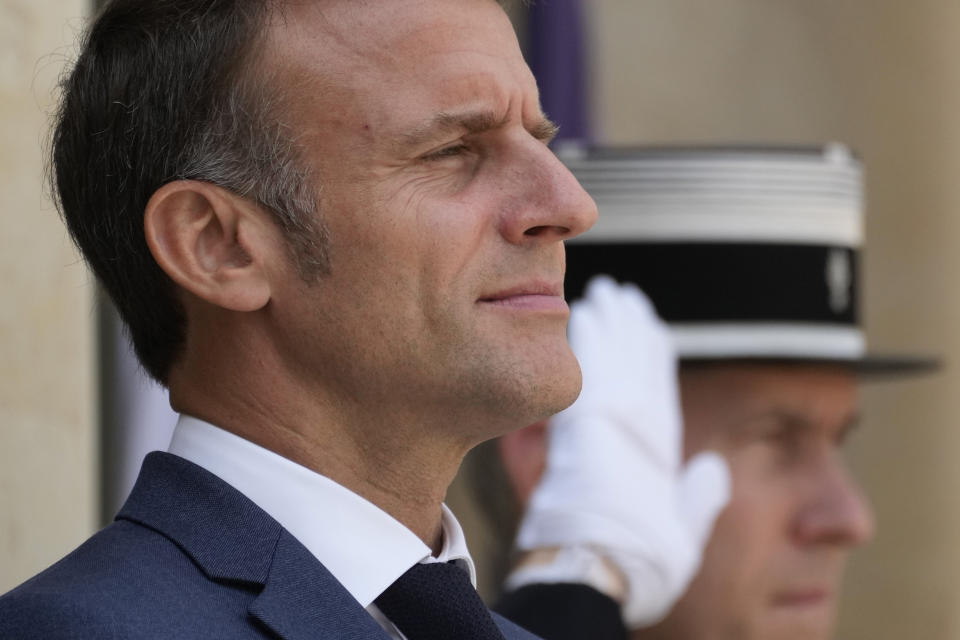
[{"x1": 636, "y1": 364, "x2": 873, "y2": 640}]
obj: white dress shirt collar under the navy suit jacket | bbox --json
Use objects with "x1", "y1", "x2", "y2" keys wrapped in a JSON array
[{"x1": 168, "y1": 415, "x2": 477, "y2": 640}]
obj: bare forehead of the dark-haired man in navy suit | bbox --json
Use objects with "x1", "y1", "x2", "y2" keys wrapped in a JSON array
[{"x1": 264, "y1": 0, "x2": 535, "y2": 119}]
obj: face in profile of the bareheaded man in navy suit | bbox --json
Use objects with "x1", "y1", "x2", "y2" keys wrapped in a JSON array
[{"x1": 255, "y1": 0, "x2": 596, "y2": 436}]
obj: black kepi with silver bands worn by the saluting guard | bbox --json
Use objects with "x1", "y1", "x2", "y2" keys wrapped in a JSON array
[{"x1": 558, "y1": 144, "x2": 938, "y2": 374}]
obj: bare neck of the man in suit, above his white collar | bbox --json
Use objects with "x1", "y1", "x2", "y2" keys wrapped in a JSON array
[{"x1": 170, "y1": 328, "x2": 473, "y2": 554}]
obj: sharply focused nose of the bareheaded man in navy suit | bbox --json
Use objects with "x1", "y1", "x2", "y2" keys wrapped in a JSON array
[{"x1": 501, "y1": 140, "x2": 597, "y2": 244}]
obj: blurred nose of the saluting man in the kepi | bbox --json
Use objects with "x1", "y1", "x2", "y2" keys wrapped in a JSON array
[{"x1": 793, "y1": 457, "x2": 874, "y2": 547}]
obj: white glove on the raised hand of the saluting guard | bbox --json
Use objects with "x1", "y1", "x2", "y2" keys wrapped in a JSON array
[{"x1": 511, "y1": 276, "x2": 730, "y2": 627}]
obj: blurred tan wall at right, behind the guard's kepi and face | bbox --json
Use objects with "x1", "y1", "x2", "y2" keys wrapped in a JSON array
[{"x1": 590, "y1": 0, "x2": 960, "y2": 640}]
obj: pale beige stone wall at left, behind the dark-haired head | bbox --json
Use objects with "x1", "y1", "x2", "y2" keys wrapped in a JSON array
[{"x1": 0, "y1": 0, "x2": 97, "y2": 593}]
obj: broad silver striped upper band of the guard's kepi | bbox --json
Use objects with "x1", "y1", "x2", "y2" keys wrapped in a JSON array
[{"x1": 558, "y1": 144, "x2": 863, "y2": 247}]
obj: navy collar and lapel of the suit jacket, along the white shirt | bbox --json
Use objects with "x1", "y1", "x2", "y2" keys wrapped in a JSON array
[{"x1": 117, "y1": 452, "x2": 389, "y2": 640}]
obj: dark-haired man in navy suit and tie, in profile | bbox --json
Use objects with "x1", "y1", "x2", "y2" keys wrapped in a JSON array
[{"x1": 0, "y1": 0, "x2": 596, "y2": 640}]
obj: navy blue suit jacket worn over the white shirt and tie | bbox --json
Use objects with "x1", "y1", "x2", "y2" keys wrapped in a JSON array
[{"x1": 0, "y1": 453, "x2": 536, "y2": 640}]
